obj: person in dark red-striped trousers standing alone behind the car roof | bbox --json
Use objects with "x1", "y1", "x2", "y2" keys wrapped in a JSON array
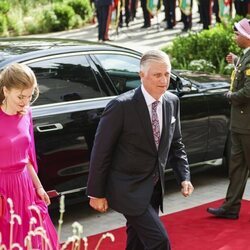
[{"x1": 94, "y1": 0, "x2": 113, "y2": 41}]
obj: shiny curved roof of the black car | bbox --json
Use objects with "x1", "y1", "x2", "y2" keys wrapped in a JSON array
[{"x1": 0, "y1": 38, "x2": 141, "y2": 68}]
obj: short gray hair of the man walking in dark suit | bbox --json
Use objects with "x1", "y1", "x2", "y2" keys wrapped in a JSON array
[{"x1": 140, "y1": 50, "x2": 171, "y2": 70}]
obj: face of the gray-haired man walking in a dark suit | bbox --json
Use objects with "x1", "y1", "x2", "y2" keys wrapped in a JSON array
[{"x1": 140, "y1": 61, "x2": 170, "y2": 100}]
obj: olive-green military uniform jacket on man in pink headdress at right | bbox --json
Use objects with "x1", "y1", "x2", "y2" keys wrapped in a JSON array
[{"x1": 231, "y1": 50, "x2": 250, "y2": 134}]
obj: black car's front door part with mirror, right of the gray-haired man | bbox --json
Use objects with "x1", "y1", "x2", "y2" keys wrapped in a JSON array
[{"x1": 169, "y1": 74, "x2": 209, "y2": 165}]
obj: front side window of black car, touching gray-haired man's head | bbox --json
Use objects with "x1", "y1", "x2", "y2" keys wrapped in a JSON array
[{"x1": 95, "y1": 54, "x2": 141, "y2": 94}]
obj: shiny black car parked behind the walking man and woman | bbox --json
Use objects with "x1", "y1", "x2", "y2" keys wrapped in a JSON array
[{"x1": 0, "y1": 39, "x2": 230, "y2": 203}]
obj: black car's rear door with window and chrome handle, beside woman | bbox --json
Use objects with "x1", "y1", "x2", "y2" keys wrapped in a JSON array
[{"x1": 26, "y1": 52, "x2": 113, "y2": 197}]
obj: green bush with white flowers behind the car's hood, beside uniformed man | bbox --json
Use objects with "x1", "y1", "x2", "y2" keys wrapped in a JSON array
[{"x1": 162, "y1": 17, "x2": 245, "y2": 74}]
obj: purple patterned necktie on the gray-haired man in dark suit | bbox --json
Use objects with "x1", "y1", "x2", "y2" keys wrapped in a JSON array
[{"x1": 151, "y1": 101, "x2": 161, "y2": 185}]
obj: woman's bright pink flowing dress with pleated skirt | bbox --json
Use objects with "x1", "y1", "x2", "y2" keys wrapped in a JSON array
[{"x1": 0, "y1": 108, "x2": 58, "y2": 250}]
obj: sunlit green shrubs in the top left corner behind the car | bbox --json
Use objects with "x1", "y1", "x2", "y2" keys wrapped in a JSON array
[{"x1": 0, "y1": 0, "x2": 93, "y2": 36}]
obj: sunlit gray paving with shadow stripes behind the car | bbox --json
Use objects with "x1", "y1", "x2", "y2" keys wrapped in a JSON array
[{"x1": 30, "y1": 2, "x2": 202, "y2": 52}]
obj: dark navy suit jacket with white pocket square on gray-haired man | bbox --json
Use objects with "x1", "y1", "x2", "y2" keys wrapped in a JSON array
[{"x1": 87, "y1": 87, "x2": 190, "y2": 216}]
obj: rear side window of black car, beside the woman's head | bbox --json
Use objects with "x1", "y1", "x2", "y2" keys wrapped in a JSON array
[{"x1": 28, "y1": 55, "x2": 103, "y2": 105}]
